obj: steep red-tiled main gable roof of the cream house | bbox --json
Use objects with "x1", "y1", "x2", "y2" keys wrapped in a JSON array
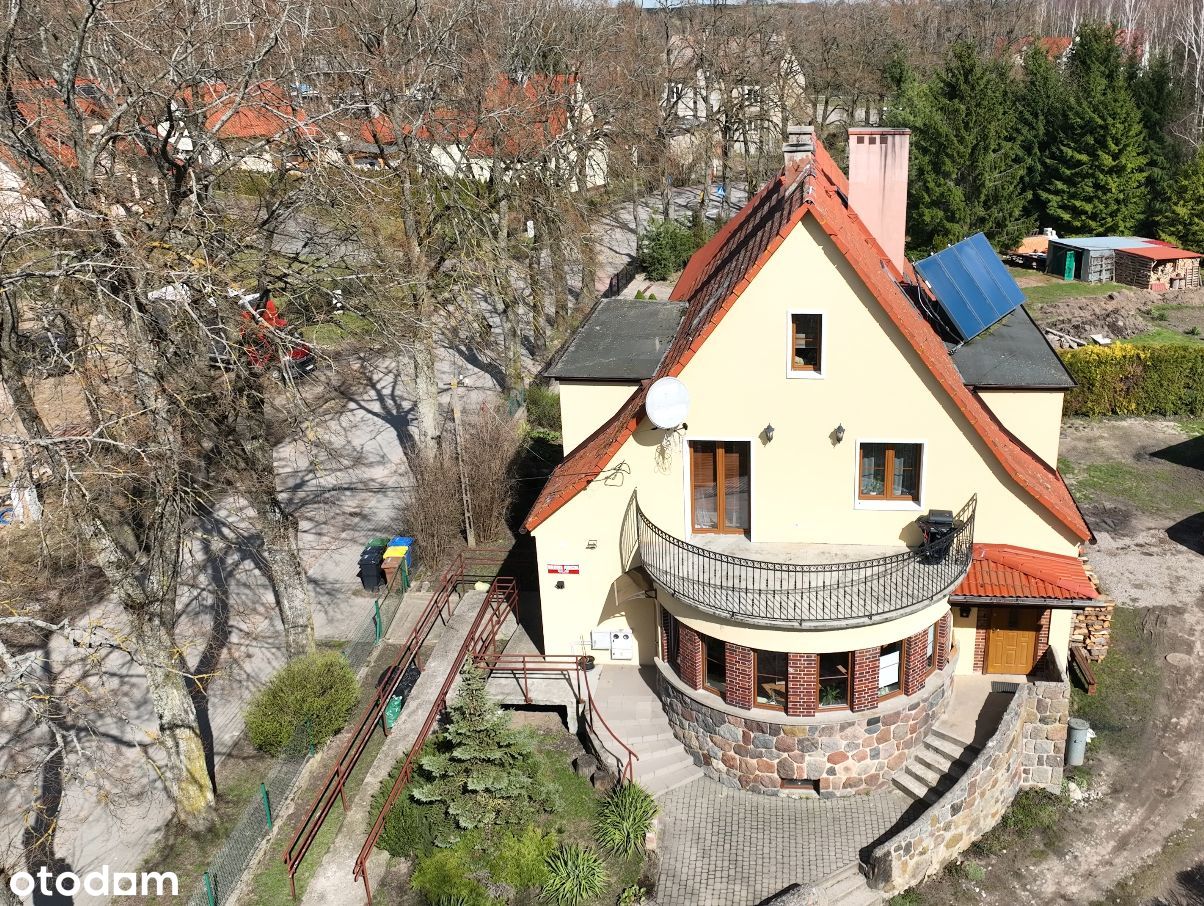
[{"x1": 524, "y1": 133, "x2": 1092, "y2": 541}]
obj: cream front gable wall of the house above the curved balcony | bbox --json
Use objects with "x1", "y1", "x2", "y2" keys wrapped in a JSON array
[{"x1": 533, "y1": 218, "x2": 1078, "y2": 670}]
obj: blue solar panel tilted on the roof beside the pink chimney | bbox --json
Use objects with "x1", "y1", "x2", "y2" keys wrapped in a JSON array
[{"x1": 915, "y1": 233, "x2": 1025, "y2": 342}]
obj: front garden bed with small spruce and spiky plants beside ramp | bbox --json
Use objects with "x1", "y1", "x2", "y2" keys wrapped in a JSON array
[{"x1": 373, "y1": 669, "x2": 656, "y2": 906}]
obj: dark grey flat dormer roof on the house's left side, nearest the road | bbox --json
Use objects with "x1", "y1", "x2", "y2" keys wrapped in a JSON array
[{"x1": 543, "y1": 299, "x2": 685, "y2": 381}]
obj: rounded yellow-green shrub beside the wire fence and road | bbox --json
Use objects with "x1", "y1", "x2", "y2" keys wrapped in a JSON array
[{"x1": 244, "y1": 652, "x2": 360, "y2": 755}]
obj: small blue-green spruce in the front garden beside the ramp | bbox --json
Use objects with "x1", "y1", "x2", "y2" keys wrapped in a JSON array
[{"x1": 411, "y1": 663, "x2": 554, "y2": 845}]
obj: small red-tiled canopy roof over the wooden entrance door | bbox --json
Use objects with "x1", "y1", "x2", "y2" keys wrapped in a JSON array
[{"x1": 954, "y1": 545, "x2": 1099, "y2": 601}]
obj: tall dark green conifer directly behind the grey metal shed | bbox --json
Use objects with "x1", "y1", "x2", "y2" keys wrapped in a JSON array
[{"x1": 1040, "y1": 25, "x2": 1146, "y2": 236}]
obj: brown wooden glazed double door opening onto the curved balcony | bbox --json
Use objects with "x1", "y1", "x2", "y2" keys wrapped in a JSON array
[{"x1": 690, "y1": 441, "x2": 753, "y2": 535}]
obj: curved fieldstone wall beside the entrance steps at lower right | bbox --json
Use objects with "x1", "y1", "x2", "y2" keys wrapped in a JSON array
[{"x1": 868, "y1": 682, "x2": 1070, "y2": 896}]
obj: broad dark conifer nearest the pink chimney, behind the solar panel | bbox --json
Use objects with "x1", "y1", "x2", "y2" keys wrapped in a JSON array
[{"x1": 892, "y1": 43, "x2": 1027, "y2": 255}]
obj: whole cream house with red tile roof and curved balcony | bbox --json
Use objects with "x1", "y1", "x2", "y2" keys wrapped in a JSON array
[{"x1": 525, "y1": 128, "x2": 1104, "y2": 798}]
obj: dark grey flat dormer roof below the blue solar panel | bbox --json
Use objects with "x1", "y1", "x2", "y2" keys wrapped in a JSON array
[{"x1": 950, "y1": 306, "x2": 1074, "y2": 390}]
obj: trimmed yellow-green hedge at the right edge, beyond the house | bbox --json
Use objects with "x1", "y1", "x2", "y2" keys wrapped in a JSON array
[{"x1": 1060, "y1": 343, "x2": 1204, "y2": 418}]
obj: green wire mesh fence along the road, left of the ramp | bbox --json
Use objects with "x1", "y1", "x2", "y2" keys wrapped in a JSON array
[{"x1": 189, "y1": 567, "x2": 413, "y2": 906}]
